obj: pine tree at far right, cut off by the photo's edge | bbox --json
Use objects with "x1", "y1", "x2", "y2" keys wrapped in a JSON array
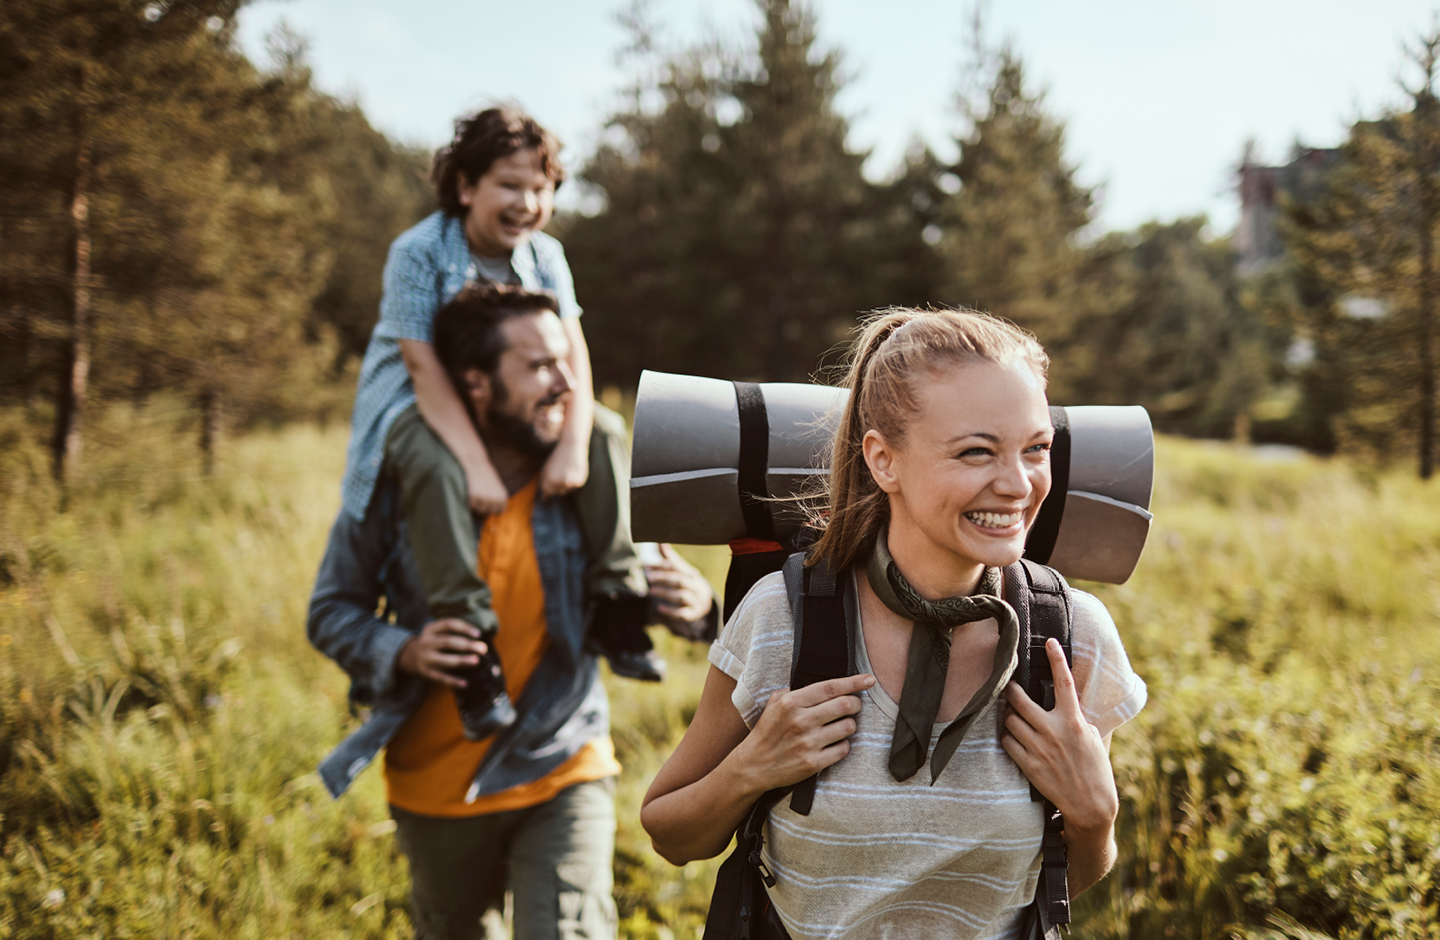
[{"x1": 1283, "y1": 27, "x2": 1440, "y2": 478}]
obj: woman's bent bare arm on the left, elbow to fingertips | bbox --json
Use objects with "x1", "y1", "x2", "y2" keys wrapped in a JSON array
[{"x1": 639, "y1": 666, "x2": 876, "y2": 865}]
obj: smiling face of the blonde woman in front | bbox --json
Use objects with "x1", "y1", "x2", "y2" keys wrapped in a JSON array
[{"x1": 865, "y1": 361, "x2": 1054, "y2": 571}]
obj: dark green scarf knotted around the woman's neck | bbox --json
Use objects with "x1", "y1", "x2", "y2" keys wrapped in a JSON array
[{"x1": 865, "y1": 531, "x2": 1020, "y2": 785}]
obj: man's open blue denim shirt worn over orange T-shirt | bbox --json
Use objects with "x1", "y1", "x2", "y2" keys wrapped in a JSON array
[{"x1": 307, "y1": 481, "x2": 611, "y2": 800}]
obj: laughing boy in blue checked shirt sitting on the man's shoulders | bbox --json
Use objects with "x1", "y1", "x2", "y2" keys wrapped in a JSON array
[{"x1": 343, "y1": 107, "x2": 664, "y2": 740}]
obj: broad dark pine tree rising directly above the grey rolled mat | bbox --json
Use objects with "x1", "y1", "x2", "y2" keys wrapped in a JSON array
[{"x1": 566, "y1": 0, "x2": 886, "y2": 384}]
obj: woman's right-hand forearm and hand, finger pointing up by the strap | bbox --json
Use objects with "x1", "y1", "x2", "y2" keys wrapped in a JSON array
[{"x1": 1001, "y1": 639, "x2": 1120, "y2": 897}]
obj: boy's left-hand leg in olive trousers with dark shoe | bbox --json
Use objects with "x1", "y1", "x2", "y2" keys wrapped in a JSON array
[{"x1": 384, "y1": 406, "x2": 516, "y2": 740}]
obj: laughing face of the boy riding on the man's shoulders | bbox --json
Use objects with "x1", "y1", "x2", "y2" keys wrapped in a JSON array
[{"x1": 458, "y1": 147, "x2": 554, "y2": 258}]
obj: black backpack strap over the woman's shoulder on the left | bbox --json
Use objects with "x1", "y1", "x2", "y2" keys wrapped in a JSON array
[{"x1": 783, "y1": 551, "x2": 854, "y2": 816}]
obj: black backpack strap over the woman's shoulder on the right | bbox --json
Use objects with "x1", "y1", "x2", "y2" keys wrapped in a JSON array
[{"x1": 1005, "y1": 559, "x2": 1074, "y2": 933}]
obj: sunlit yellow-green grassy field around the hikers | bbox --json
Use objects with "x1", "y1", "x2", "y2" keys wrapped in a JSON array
[{"x1": 0, "y1": 407, "x2": 1440, "y2": 939}]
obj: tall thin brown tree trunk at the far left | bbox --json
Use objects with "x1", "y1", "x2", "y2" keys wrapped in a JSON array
[{"x1": 50, "y1": 66, "x2": 91, "y2": 482}]
